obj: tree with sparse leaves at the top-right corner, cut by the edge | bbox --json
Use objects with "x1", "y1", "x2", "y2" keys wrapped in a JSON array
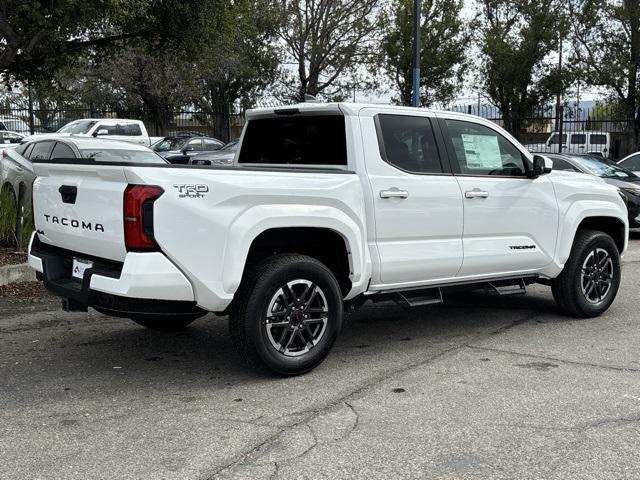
[{"x1": 571, "y1": 0, "x2": 640, "y2": 150}]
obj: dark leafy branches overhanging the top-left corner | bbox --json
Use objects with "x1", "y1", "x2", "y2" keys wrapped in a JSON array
[{"x1": 0, "y1": 0, "x2": 218, "y2": 80}]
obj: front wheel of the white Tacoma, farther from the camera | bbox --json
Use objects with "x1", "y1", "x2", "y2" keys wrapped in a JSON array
[{"x1": 551, "y1": 230, "x2": 621, "y2": 318}]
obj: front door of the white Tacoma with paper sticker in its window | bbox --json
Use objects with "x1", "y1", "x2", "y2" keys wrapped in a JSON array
[{"x1": 441, "y1": 119, "x2": 558, "y2": 277}]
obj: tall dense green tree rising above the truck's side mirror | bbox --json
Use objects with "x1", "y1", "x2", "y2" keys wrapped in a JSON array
[{"x1": 479, "y1": 0, "x2": 566, "y2": 138}]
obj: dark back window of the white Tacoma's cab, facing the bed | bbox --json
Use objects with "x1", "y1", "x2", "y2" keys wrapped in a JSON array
[{"x1": 238, "y1": 115, "x2": 347, "y2": 165}]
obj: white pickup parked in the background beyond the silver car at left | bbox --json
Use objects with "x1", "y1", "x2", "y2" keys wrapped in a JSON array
[{"x1": 24, "y1": 118, "x2": 163, "y2": 147}]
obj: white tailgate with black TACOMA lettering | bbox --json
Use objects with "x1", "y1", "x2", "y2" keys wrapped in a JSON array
[{"x1": 33, "y1": 163, "x2": 127, "y2": 261}]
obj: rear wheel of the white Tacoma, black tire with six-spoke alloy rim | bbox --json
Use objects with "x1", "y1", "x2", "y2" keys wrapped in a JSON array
[{"x1": 229, "y1": 254, "x2": 342, "y2": 375}]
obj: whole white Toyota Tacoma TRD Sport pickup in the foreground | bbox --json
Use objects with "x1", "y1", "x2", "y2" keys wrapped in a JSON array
[{"x1": 29, "y1": 104, "x2": 628, "y2": 375}]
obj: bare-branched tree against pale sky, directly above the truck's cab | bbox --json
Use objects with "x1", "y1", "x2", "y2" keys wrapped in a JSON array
[{"x1": 279, "y1": 0, "x2": 378, "y2": 101}]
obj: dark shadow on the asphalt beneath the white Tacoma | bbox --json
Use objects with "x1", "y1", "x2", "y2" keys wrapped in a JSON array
[{"x1": 28, "y1": 293, "x2": 562, "y2": 390}]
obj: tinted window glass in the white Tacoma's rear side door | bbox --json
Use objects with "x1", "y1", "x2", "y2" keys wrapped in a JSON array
[{"x1": 378, "y1": 115, "x2": 442, "y2": 173}]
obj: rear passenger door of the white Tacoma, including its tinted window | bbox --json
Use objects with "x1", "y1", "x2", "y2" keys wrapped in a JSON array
[{"x1": 360, "y1": 109, "x2": 462, "y2": 286}]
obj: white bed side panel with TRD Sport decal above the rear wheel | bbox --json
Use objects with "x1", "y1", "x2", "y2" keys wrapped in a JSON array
[{"x1": 127, "y1": 168, "x2": 371, "y2": 311}]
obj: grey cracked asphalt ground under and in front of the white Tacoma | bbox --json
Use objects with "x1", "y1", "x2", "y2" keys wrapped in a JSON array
[{"x1": 0, "y1": 234, "x2": 640, "y2": 480}]
